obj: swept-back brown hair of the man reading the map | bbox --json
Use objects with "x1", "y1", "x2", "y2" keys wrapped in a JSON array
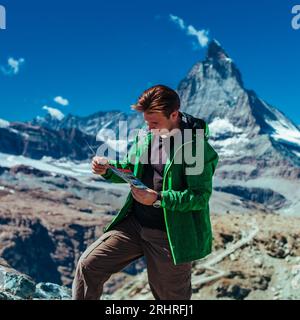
[{"x1": 132, "y1": 85, "x2": 180, "y2": 118}]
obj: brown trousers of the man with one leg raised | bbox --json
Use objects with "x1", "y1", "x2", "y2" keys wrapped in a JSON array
[{"x1": 72, "y1": 215, "x2": 192, "y2": 300}]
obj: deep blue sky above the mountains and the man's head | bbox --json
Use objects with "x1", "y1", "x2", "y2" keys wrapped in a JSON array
[{"x1": 0, "y1": 0, "x2": 300, "y2": 124}]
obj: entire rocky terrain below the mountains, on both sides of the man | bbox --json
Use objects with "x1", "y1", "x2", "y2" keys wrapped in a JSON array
[{"x1": 0, "y1": 165, "x2": 300, "y2": 299}]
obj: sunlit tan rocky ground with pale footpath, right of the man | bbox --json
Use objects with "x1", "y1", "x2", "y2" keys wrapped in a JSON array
[{"x1": 103, "y1": 212, "x2": 300, "y2": 300}]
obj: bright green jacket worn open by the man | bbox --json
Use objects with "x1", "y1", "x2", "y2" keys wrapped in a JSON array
[{"x1": 102, "y1": 113, "x2": 219, "y2": 265}]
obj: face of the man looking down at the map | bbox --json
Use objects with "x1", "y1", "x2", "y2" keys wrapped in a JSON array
[{"x1": 144, "y1": 111, "x2": 178, "y2": 134}]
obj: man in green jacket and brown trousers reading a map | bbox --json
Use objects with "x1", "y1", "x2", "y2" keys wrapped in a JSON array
[{"x1": 73, "y1": 85, "x2": 218, "y2": 300}]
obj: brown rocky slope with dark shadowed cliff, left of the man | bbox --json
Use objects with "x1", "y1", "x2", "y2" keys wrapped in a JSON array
[{"x1": 0, "y1": 165, "x2": 144, "y2": 287}]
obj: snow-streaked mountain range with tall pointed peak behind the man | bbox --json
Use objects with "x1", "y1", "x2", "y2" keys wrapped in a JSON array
[{"x1": 0, "y1": 40, "x2": 300, "y2": 214}]
